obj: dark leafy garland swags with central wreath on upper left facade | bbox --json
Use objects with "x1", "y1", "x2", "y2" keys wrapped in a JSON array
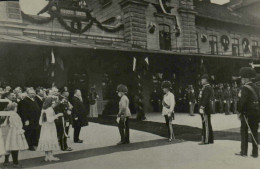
[{"x1": 21, "y1": 1, "x2": 124, "y2": 34}]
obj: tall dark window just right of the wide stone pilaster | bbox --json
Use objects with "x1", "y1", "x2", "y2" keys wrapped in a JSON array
[{"x1": 159, "y1": 24, "x2": 171, "y2": 50}]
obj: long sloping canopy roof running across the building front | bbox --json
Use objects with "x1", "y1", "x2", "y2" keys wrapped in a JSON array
[{"x1": 0, "y1": 34, "x2": 260, "y2": 61}]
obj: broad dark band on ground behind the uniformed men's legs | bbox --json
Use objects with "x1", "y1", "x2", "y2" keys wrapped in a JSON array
[{"x1": 90, "y1": 116, "x2": 260, "y2": 142}]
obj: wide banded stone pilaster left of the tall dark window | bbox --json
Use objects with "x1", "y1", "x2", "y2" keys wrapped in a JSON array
[{"x1": 120, "y1": 0, "x2": 148, "y2": 48}]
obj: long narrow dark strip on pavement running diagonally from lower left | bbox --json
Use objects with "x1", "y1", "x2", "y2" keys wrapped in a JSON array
[{"x1": 6, "y1": 139, "x2": 183, "y2": 169}]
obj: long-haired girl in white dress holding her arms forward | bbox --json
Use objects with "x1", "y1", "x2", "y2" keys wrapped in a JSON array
[{"x1": 37, "y1": 97, "x2": 63, "y2": 161}]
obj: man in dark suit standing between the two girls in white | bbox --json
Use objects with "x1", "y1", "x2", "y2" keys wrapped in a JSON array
[{"x1": 19, "y1": 89, "x2": 41, "y2": 150}]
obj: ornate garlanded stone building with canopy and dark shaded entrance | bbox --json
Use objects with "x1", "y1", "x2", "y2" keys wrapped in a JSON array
[{"x1": 0, "y1": 0, "x2": 260, "y2": 113}]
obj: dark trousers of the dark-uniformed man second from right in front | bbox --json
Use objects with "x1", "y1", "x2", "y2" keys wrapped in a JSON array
[{"x1": 201, "y1": 114, "x2": 214, "y2": 144}]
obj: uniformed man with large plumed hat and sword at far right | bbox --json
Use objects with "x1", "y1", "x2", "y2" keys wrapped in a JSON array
[{"x1": 236, "y1": 67, "x2": 259, "y2": 158}]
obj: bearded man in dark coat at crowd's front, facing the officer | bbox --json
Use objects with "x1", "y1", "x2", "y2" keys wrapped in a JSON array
[{"x1": 71, "y1": 89, "x2": 88, "y2": 143}]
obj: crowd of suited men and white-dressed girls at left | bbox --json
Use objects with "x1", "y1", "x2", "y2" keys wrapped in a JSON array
[{"x1": 0, "y1": 86, "x2": 95, "y2": 168}]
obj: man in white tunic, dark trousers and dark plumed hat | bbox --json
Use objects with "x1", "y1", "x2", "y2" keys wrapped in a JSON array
[{"x1": 162, "y1": 81, "x2": 175, "y2": 141}]
